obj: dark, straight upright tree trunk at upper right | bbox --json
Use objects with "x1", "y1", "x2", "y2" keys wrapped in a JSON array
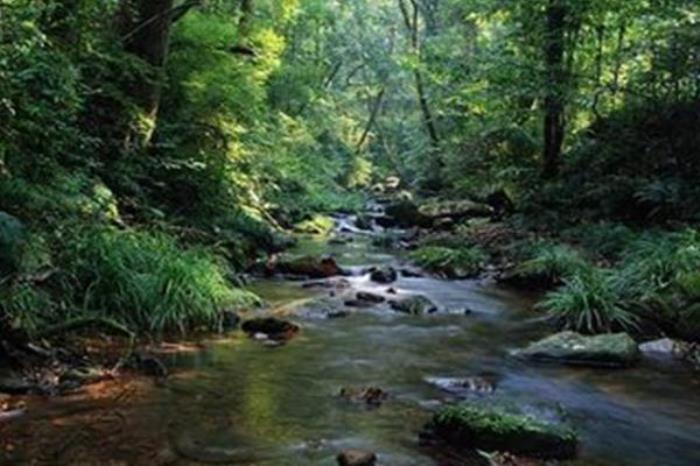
[{"x1": 543, "y1": 0, "x2": 567, "y2": 178}]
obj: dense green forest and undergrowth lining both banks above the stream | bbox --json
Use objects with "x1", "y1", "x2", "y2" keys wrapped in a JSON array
[{"x1": 0, "y1": 0, "x2": 700, "y2": 338}]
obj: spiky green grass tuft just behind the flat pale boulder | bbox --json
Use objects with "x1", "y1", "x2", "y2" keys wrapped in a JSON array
[{"x1": 538, "y1": 269, "x2": 637, "y2": 334}]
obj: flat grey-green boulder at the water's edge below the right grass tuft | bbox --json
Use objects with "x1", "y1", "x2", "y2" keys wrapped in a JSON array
[{"x1": 513, "y1": 332, "x2": 639, "y2": 367}]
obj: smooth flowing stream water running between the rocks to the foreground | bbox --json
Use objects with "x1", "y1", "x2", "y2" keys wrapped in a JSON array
[{"x1": 0, "y1": 220, "x2": 700, "y2": 466}]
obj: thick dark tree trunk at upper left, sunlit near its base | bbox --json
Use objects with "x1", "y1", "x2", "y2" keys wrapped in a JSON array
[{"x1": 119, "y1": 0, "x2": 178, "y2": 151}]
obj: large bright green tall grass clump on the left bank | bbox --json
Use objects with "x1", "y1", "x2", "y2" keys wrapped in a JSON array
[{"x1": 64, "y1": 227, "x2": 257, "y2": 334}]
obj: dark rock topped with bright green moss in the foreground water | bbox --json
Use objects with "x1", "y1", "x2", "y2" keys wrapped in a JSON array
[{"x1": 429, "y1": 404, "x2": 578, "y2": 459}]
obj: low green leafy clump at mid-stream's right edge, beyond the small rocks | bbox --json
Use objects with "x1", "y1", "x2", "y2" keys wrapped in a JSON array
[{"x1": 411, "y1": 246, "x2": 488, "y2": 278}]
